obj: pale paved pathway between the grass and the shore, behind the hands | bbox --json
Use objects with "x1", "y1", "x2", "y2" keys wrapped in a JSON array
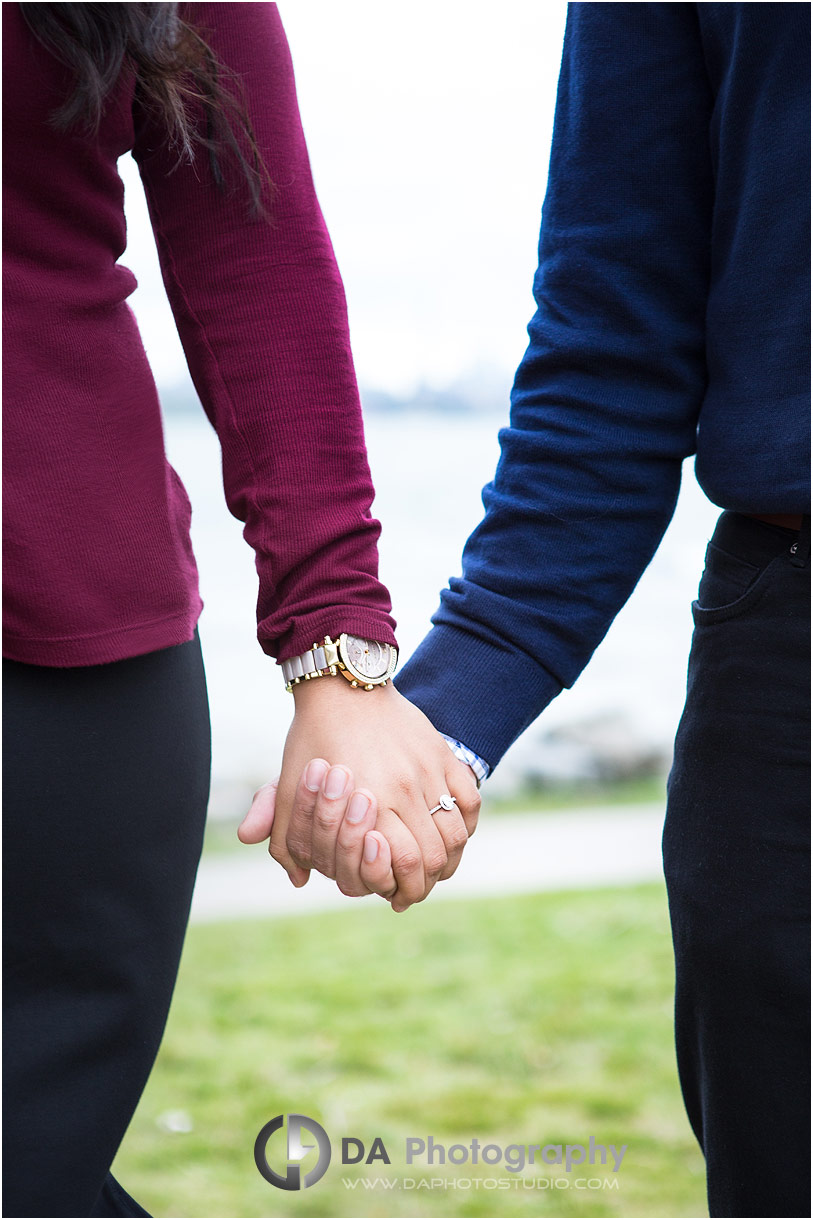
[{"x1": 192, "y1": 804, "x2": 663, "y2": 922}]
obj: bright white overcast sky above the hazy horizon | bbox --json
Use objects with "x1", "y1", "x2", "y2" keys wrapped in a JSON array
[{"x1": 120, "y1": 0, "x2": 565, "y2": 397}]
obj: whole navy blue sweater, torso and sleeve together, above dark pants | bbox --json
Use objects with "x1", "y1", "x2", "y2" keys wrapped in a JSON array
[{"x1": 397, "y1": 2, "x2": 811, "y2": 766}]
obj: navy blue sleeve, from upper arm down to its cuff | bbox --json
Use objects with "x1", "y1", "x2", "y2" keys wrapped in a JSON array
[{"x1": 397, "y1": 2, "x2": 713, "y2": 766}]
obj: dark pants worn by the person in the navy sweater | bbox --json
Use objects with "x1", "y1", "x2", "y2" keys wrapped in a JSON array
[{"x1": 663, "y1": 512, "x2": 811, "y2": 1216}]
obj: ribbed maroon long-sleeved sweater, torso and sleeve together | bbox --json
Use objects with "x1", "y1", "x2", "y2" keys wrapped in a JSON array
[{"x1": 2, "y1": 4, "x2": 394, "y2": 666}]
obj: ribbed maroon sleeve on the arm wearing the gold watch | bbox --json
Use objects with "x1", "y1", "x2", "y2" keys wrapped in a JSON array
[{"x1": 133, "y1": 4, "x2": 394, "y2": 660}]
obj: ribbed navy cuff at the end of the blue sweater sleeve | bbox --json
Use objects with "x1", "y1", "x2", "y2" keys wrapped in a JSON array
[{"x1": 393, "y1": 623, "x2": 562, "y2": 770}]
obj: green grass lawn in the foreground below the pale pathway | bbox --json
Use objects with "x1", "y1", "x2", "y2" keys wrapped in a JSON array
[{"x1": 114, "y1": 885, "x2": 707, "y2": 1218}]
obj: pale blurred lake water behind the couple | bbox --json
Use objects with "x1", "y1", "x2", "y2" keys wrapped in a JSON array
[{"x1": 166, "y1": 411, "x2": 719, "y2": 808}]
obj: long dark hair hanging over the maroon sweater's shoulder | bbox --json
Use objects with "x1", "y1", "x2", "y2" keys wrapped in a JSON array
[{"x1": 20, "y1": 4, "x2": 273, "y2": 218}]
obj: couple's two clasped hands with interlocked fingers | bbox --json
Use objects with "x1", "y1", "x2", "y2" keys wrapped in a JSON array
[{"x1": 234, "y1": 677, "x2": 480, "y2": 910}]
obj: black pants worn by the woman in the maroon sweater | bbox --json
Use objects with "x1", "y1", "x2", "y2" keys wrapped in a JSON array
[{"x1": 2, "y1": 632, "x2": 210, "y2": 1216}]
